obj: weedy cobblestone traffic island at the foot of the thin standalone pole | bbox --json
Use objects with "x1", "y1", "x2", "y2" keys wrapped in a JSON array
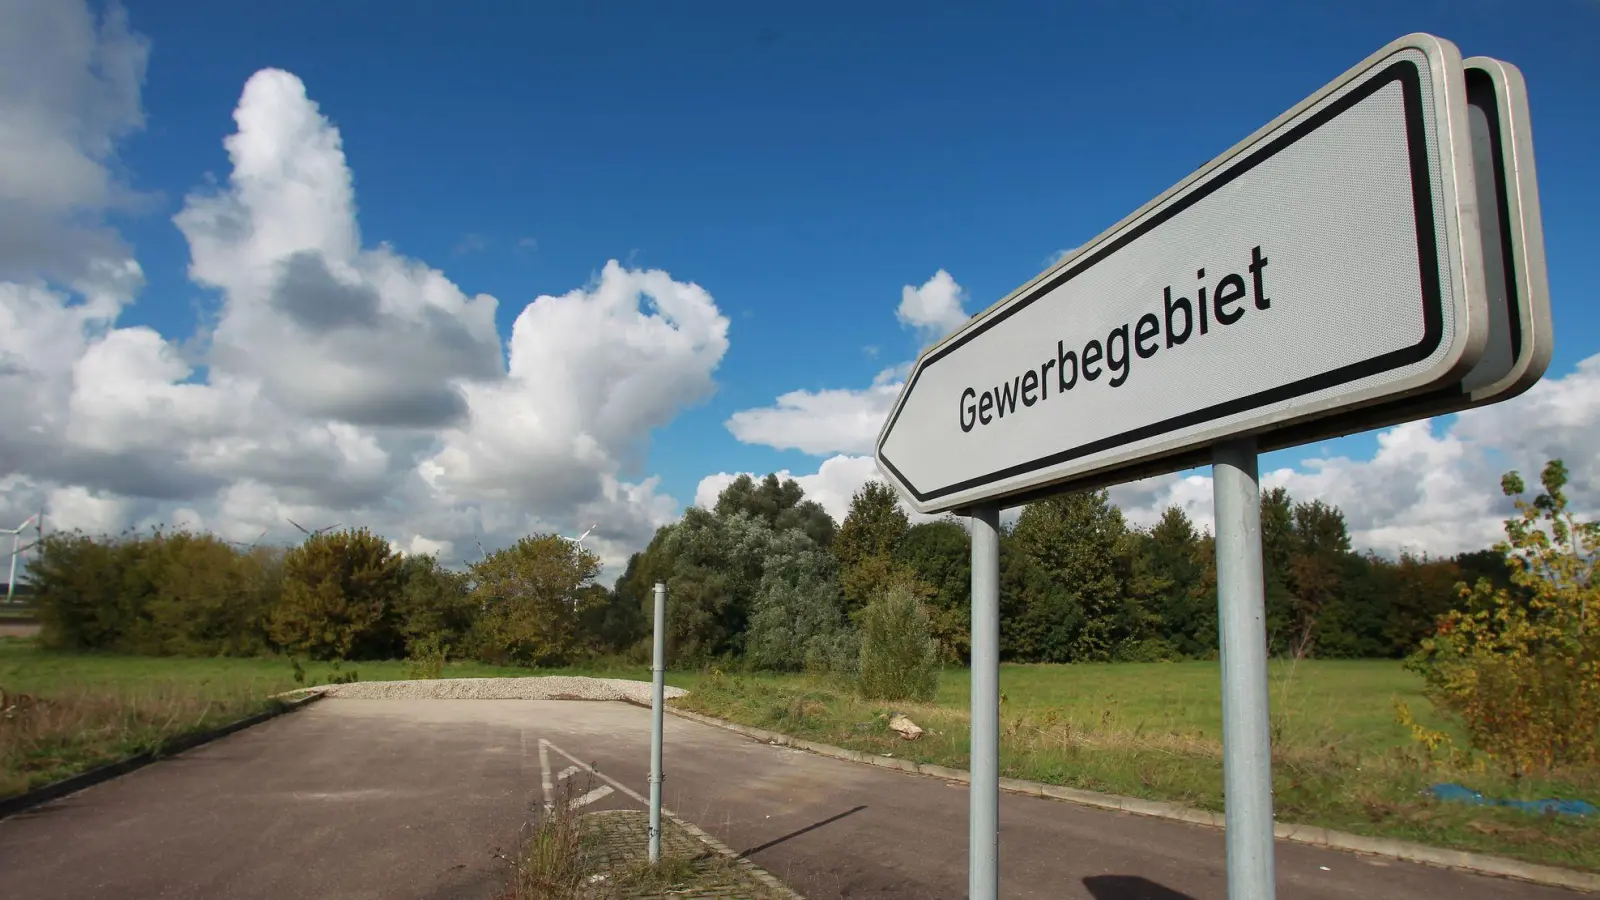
[{"x1": 581, "y1": 809, "x2": 803, "y2": 900}]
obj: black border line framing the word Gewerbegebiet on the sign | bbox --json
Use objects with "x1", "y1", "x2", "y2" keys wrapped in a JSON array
[{"x1": 877, "y1": 59, "x2": 1445, "y2": 501}]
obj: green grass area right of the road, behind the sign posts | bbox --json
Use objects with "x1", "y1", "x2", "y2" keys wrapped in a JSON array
[{"x1": 674, "y1": 661, "x2": 1600, "y2": 871}]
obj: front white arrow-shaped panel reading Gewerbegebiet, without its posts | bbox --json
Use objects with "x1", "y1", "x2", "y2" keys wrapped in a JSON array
[{"x1": 877, "y1": 35, "x2": 1510, "y2": 512}]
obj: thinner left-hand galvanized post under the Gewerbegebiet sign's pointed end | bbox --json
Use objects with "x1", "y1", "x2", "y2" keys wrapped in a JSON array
[{"x1": 966, "y1": 504, "x2": 1000, "y2": 900}]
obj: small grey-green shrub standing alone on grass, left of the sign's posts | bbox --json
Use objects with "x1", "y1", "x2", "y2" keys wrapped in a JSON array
[{"x1": 858, "y1": 580, "x2": 939, "y2": 701}]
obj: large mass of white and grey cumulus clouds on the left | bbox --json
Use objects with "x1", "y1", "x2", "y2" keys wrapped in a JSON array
[{"x1": 0, "y1": 2, "x2": 728, "y2": 569}]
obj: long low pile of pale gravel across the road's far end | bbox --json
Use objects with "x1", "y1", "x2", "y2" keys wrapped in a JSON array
[{"x1": 276, "y1": 676, "x2": 688, "y2": 706}]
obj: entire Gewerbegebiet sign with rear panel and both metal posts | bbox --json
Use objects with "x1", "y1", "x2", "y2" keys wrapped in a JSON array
[{"x1": 875, "y1": 34, "x2": 1550, "y2": 900}]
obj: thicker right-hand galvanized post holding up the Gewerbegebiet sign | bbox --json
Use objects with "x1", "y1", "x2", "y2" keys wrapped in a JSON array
[{"x1": 1211, "y1": 437, "x2": 1277, "y2": 900}]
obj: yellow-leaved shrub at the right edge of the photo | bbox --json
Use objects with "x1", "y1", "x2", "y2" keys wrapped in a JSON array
[{"x1": 1406, "y1": 460, "x2": 1600, "y2": 775}]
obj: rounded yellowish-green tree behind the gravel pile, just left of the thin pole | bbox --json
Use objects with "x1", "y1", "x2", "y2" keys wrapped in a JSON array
[{"x1": 470, "y1": 535, "x2": 600, "y2": 666}]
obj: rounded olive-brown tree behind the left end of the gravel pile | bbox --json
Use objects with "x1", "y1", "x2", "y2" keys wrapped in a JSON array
[{"x1": 270, "y1": 528, "x2": 403, "y2": 660}]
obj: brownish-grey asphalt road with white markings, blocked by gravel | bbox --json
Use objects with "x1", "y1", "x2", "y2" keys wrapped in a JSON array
[{"x1": 0, "y1": 700, "x2": 1578, "y2": 900}]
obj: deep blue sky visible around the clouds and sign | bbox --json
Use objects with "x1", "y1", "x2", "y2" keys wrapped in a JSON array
[{"x1": 3, "y1": 0, "x2": 1600, "y2": 570}]
